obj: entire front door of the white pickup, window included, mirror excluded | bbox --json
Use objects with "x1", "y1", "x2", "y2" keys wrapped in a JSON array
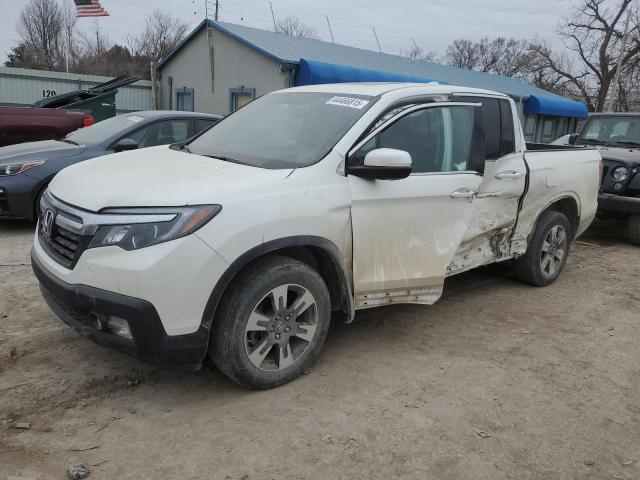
[{"x1": 347, "y1": 103, "x2": 484, "y2": 308}]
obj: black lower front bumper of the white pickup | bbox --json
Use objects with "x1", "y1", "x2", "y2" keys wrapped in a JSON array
[{"x1": 31, "y1": 249, "x2": 209, "y2": 370}]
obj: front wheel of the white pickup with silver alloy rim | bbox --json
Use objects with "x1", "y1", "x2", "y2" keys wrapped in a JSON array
[{"x1": 209, "y1": 255, "x2": 331, "y2": 389}]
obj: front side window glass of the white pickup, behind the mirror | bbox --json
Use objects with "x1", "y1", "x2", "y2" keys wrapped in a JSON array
[{"x1": 349, "y1": 105, "x2": 474, "y2": 173}]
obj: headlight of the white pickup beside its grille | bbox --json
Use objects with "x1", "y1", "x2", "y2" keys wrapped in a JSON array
[{"x1": 88, "y1": 205, "x2": 222, "y2": 250}]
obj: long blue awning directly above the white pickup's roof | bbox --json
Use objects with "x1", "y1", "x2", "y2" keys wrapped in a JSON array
[{"x1": 296, "y1": 58, "x2": 442, "y2": 87}]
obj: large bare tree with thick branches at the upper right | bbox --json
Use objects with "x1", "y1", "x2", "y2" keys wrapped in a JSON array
[{"x1": 532, "y1": 0, "x2": 640, "y2": 112}]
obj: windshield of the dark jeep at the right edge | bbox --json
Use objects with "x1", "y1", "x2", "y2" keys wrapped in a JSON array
[{"x1": 576, "y1": 115, "x2": 640, "y2": 146}]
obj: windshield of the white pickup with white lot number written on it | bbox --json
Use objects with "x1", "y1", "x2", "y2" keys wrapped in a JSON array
[{"x1": 188, "y1": 92, "x2": 376, "y2": 169}]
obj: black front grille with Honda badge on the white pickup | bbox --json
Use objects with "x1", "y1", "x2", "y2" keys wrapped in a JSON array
[{"x1": 38, "y1": 196, "x2": 92, "y2": 269}]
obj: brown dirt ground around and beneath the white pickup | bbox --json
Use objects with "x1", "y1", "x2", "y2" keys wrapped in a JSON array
[{"x1": 0, "y1": 221, "x2": 640, "y2": 480}]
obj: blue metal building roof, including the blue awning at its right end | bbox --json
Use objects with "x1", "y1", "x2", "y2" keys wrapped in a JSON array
[{"x1": 157, "y1": 20, "x2": 586, "y2": 118}]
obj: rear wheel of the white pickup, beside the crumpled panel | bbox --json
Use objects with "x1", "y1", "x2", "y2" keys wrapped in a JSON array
[{"x1": 514, "y1": 211, "x2": 573, "y2": 287}]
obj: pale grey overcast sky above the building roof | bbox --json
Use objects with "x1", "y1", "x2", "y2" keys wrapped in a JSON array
[{"x1": 0, "y1": 0, "x2": 576, "y2": 63}]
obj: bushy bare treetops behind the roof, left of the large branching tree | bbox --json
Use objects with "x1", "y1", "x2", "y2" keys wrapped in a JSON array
[{"x1": 447, "y1": 37, "x2": 531, "y2": 78}]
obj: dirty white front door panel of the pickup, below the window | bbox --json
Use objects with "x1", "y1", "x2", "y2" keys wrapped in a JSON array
[{"x1": 348, "y1": 172, "x2": 481, "y2": 308}]
